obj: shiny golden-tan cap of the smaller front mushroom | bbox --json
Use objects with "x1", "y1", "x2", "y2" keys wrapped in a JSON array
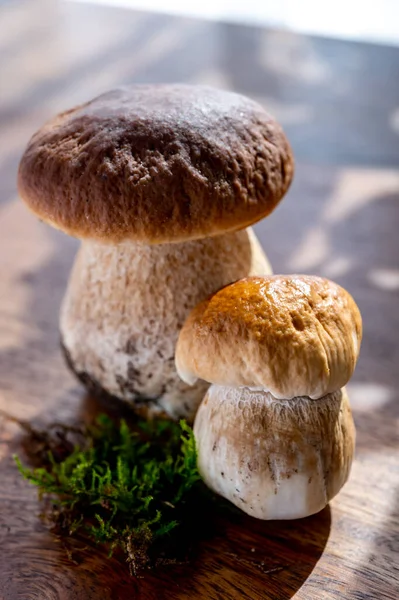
[{"x1": 176, "y1": 275, "x2": 362, "y2": 398}]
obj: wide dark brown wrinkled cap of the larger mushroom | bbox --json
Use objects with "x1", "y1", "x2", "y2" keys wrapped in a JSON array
[{"x1": 18, "y1": 85, "x2": 293, "y2": 243}]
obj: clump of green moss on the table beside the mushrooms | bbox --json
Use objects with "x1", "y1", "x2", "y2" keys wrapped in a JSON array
[{"x1": 15, "y1": 415, "x2": 199, "y2": 574}]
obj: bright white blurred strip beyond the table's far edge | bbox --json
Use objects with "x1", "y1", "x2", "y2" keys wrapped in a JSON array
[{"x1": 71, "y1": 0, "x2": 399, "y2": 45}]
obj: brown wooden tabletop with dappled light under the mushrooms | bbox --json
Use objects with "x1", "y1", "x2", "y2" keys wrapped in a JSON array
[{"x1": 0, "y1": 0, "x2": 399, "y2": 600}]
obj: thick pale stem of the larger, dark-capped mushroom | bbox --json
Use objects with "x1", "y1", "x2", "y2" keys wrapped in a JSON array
[{"x1": 60, "y1": 229, "x2": 271, "y2": 419}]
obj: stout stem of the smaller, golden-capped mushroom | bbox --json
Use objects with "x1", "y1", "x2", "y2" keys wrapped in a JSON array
[{"x1": 194, "y1": 385, "x2": 355, "y2": 519}]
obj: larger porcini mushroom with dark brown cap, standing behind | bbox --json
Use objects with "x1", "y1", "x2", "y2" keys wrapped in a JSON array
[{"x1": 19, "y1": 85, "x2": 293, "y2": 417}]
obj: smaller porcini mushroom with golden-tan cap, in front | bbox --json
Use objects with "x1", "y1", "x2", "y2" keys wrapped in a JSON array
[{"x1": 176, "y1": 275, "x2": 362, "y2": 519}]
